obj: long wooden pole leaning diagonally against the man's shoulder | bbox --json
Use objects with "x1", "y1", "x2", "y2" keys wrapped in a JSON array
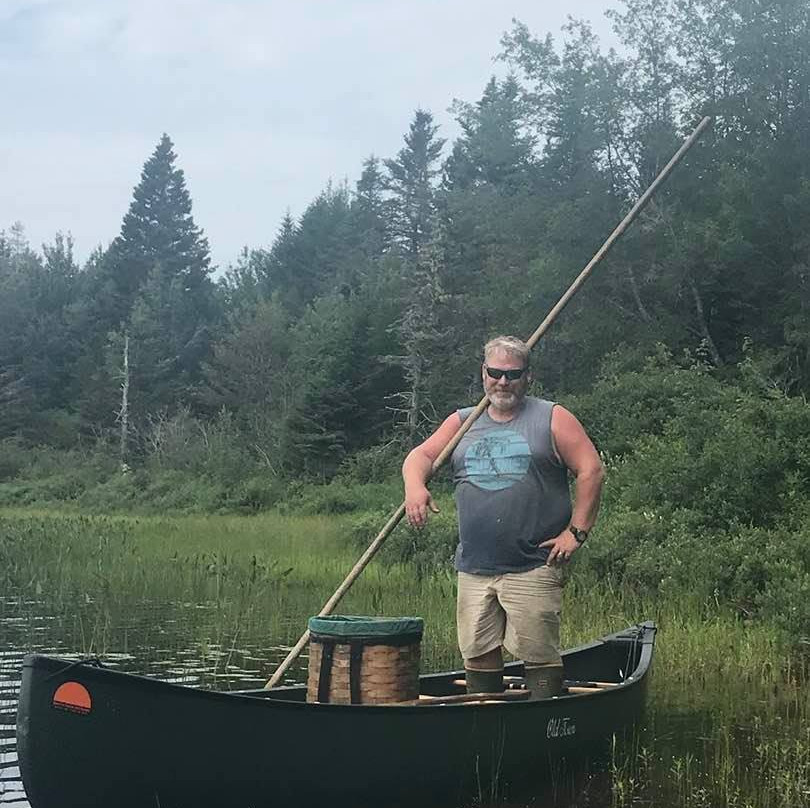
[{"x1": 265, "y1": 116, "x2": 711, "y2": 689}]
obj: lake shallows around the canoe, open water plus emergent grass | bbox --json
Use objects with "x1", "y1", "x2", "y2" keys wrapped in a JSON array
[{"x1": 0, "y1": 517, "x2": 810, "y2": 808}]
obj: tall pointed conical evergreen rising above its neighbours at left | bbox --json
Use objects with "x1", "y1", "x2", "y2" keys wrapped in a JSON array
[{"x1": 78, "y1": 134, "x2": 218, "y2": 426}]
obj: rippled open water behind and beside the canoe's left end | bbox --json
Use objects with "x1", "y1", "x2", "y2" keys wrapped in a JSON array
[{"x1": 0, "y1": 598, "x2": 308, "y2": 808}]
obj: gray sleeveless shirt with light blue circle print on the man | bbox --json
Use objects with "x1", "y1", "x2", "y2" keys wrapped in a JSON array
[{"x1": 452, "y1": 397, "x2": 571, "y2": 575}]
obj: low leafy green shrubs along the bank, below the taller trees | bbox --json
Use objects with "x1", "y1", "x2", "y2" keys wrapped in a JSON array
[{"x1": 6, "y1": 348, "x2": 810, "y2": 650}]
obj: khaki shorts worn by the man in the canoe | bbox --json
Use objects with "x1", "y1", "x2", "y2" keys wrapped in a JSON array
[{"x1": 456, "y1": 565, "x2": 563, "y2": 665}]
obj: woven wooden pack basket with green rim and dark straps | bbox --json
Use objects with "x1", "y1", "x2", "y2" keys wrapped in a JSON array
[{"x1": 307, "y1": 615, "x2": 424, "y2": 704}]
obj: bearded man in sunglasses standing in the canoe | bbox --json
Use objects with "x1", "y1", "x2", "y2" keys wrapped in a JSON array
[{"x1": 402, "y1": 337, "x2": 604, "y2": 698}]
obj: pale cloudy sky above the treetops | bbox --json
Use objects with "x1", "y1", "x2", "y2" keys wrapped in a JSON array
[{"x1": 0, "y1": 0, "x2": 617, "y2": 270}]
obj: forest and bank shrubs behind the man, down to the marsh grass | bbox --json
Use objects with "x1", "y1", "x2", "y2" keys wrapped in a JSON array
[{"x1": 0, "y1": 0, "x2": 810, "y2": 625}]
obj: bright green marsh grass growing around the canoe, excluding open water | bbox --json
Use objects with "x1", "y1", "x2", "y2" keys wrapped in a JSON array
[{"x1": 0, "y1": 508, "x2": 810, "y2": 808}]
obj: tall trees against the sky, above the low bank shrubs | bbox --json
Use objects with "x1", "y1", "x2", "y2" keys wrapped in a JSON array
[{"x1": 0, "y1": 0, "x2": 810, "y2": 478}]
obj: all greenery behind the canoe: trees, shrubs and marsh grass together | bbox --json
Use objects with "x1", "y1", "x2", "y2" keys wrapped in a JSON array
[{"x1": 0, "y1": 0, "x2": 810, "y2": 808}]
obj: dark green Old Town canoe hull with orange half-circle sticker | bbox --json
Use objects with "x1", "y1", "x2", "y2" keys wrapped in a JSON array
[{"x1": 17, "y1": 624, "x2": 655, "y2": 808}]
